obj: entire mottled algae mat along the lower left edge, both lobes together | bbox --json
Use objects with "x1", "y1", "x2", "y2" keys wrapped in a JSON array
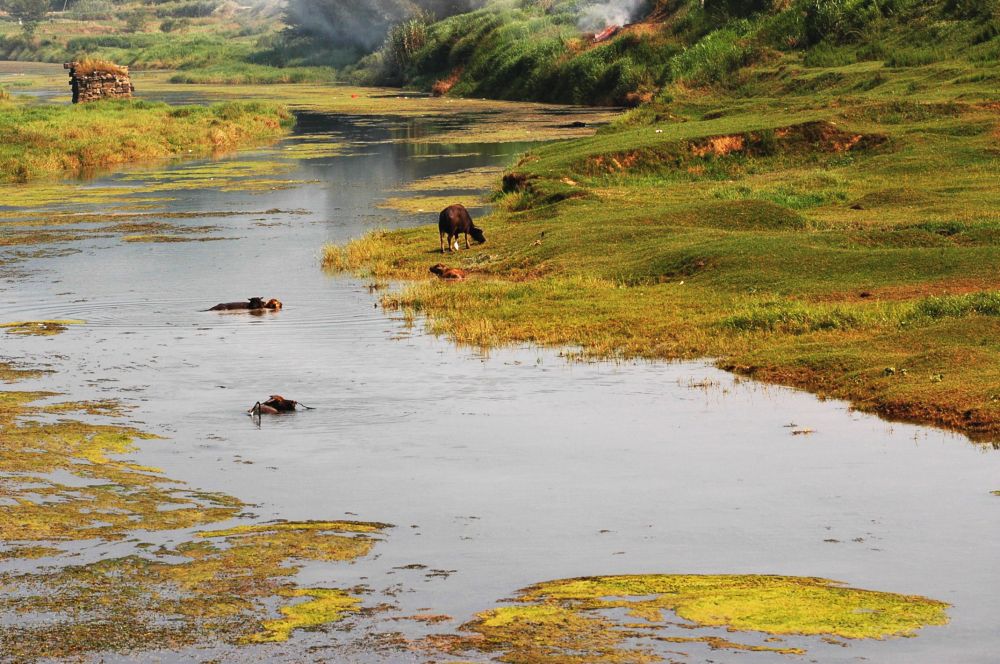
[{"x1": 0, "y1": 363, "x2": 388, "y2": 662}]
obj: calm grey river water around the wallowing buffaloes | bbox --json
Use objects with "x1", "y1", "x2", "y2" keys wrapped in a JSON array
[{"x1": 0, "y1": 72, "x2": 1000, "y2": 662}]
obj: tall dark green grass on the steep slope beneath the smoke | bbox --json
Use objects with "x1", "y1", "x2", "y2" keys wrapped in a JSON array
[{"x1": 336, "y1": 0, "x2": 1000, "y2": 105}]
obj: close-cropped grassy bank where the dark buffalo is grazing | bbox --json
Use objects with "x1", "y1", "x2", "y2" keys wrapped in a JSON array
[{"x1": 325, "y1": 55, "x2": 1000, "y2": 440}]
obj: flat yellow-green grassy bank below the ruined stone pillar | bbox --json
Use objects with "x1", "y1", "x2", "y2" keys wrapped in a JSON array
[{"x1": 0, "y1": 100, "x2": 294, "y2": 182}]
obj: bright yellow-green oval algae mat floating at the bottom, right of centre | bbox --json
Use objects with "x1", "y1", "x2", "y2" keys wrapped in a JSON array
[{"x1": 433, "y1": 574, "x2": 948, "y2": 663}]
